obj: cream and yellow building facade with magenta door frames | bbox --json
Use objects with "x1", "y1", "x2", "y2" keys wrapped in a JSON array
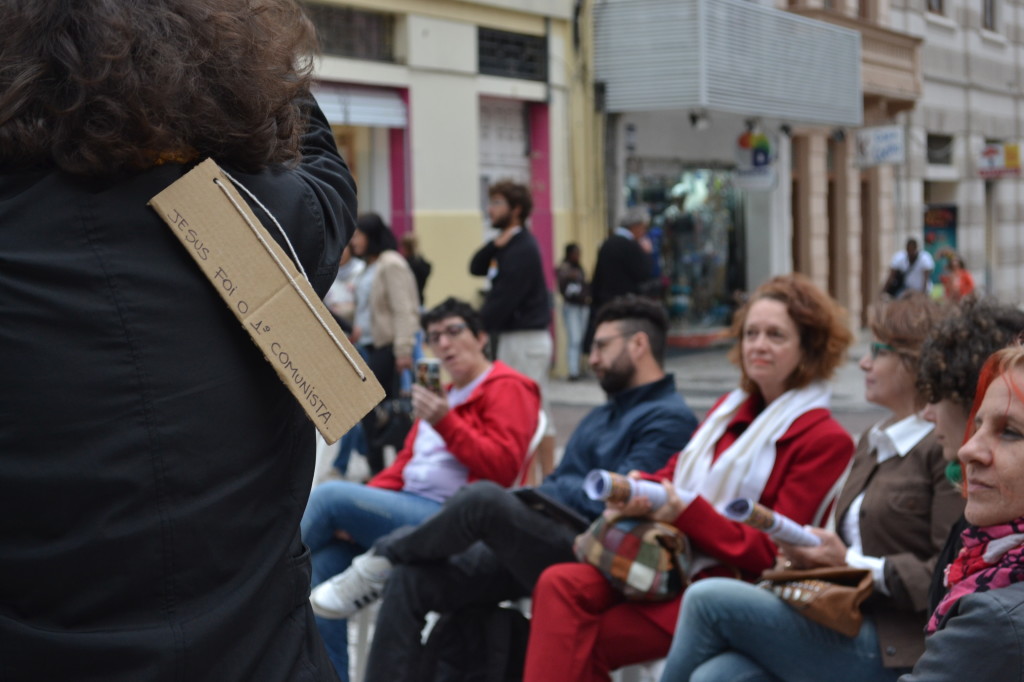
[{"x1": 305, "y1": 0, "x2": 604, "y2": 315}]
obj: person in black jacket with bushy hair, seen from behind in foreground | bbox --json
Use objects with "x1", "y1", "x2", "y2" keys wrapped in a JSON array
[{"x1": 0, "y1": 0, "x2": 356, "y2": 682}]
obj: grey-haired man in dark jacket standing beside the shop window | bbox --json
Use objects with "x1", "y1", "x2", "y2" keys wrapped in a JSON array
[{"x1": 584, "y1": 206, "x2": 650, "y2": 352}]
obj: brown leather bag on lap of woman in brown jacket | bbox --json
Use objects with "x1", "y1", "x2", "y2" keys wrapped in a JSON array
[{"x1": 758, "y1": 566, "x2": 873, "y2": 637}]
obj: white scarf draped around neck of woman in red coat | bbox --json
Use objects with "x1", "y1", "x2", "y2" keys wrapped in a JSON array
[{"x1": 673, "y1": 381, "x2": 831, "y2": 574}]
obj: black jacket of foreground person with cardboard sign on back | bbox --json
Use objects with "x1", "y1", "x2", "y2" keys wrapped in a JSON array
[{"x1": 0, "y1": 102, "x2": 355, "y2": 682}]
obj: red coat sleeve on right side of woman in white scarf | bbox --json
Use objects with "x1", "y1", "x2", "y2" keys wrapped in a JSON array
[{"x1": 676, "y1": 410, "x2": 853, "y2": 577}]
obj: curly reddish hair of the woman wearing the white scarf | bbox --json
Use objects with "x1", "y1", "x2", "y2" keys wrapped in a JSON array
[{"x1": 729, "y1": 272, "x2": 853, "y2": 393}]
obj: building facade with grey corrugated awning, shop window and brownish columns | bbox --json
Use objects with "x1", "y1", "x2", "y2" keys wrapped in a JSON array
[{"x1": 594, "y1": 0, "x2": 922, "y2": 329}]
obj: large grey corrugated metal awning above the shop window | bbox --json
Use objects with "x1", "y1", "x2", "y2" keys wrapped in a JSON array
[{"x1": 594, "y1": 0, "x2": 863, "y2": 126}]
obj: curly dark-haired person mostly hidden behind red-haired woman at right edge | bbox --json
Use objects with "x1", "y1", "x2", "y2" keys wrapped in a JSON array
[{"x1": 918, "y1": 298, "x2": 1024, "y2": 610}]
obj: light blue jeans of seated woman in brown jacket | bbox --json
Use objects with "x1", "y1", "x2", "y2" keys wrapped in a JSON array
[{"x1": 662, "y1": 578, "x2": 909, "y2": 682}]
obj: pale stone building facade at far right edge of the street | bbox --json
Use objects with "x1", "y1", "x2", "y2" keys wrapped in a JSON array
[{"x1": 889, "y1": 0, "x2": 1024, "y2": 302}]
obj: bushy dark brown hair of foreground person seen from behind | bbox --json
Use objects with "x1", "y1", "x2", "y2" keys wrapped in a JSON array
[{"x1": 0, "y1": 0, "x2": 316, "y2": 175}]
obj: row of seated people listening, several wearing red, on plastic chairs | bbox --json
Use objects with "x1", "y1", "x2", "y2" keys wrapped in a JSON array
[{"x1": 302, "y1": 274, "x2": 1024, "y2": 682}]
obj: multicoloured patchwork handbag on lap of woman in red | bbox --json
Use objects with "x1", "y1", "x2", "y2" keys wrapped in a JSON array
[{"x1": 572, "y1": 514, "x2": 690, "y2": 601}]
